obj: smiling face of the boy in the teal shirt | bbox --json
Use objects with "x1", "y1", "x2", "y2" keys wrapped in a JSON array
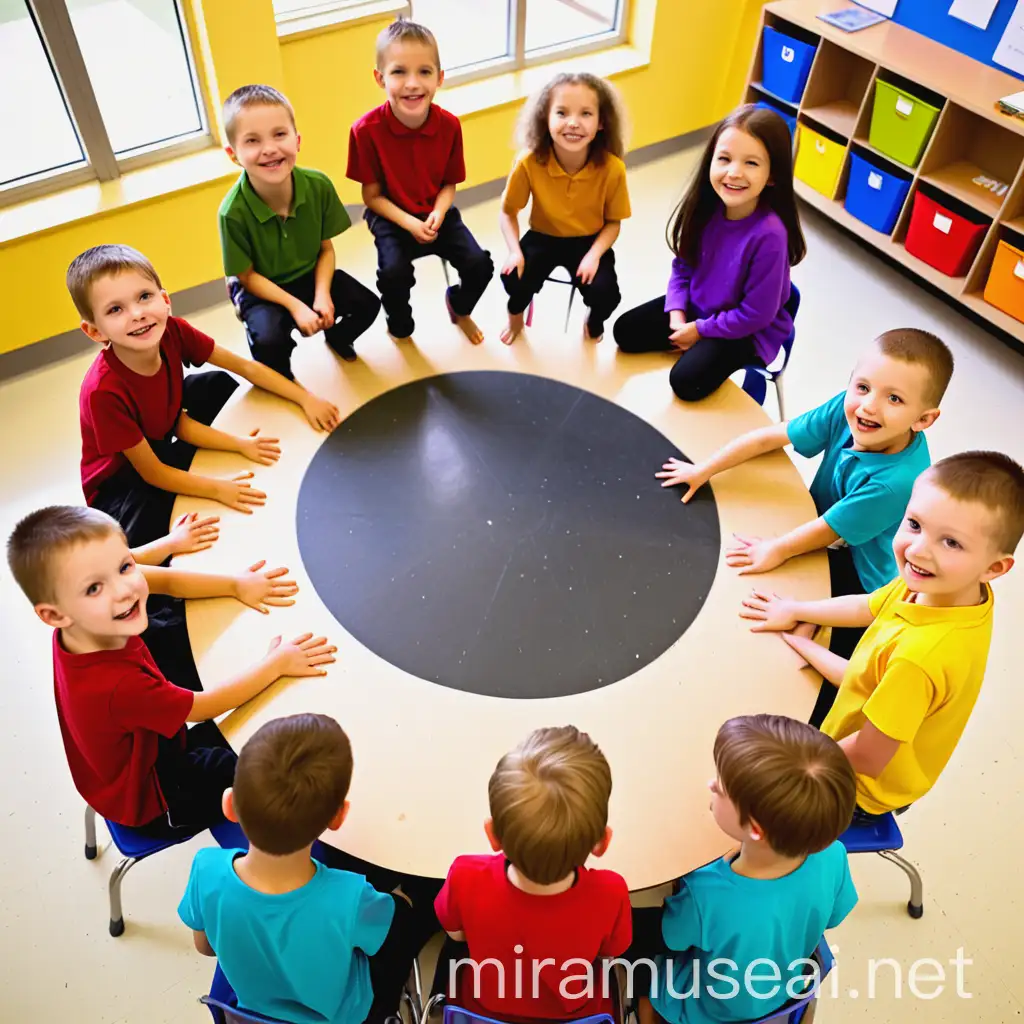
[{"x1": 843, "y1": 345, "x2": 939, "y2": 455}]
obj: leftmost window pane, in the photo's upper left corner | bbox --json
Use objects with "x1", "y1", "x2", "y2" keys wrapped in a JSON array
[{"x1": 0, "y1": 0, "x2": 84, "y2": 185}]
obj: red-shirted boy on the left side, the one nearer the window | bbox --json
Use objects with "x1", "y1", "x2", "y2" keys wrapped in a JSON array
[{"x1": 68, "y1": 245, "x2": 338, "y2": 547}]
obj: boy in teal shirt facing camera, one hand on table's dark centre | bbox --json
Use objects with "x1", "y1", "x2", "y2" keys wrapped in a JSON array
[{"x1": 656, "y1": 329, "x2": 953, "y2": 725}]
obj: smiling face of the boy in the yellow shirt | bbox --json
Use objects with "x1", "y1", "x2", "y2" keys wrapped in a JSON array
[{"x1": 893, "y1": 471, "x2": 1013, "y2": 605}]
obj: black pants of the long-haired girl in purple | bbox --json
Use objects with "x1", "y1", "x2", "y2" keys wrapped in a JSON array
[{"x1": 614, "y1": 295, "x2": 765, "y2": 401}]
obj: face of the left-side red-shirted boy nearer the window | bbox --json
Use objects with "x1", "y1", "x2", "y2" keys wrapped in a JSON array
[{"x1": 82, "y1": 270, "x2": 171, "y2": 355}]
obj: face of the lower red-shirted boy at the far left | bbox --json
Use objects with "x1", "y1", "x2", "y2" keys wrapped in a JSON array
[{"x1": 36, "y1": 531, "x2": 150, "y2": 649}]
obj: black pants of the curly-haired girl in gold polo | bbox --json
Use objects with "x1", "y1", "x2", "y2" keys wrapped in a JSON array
[{"x1": 502, "y1": 231, "x2": 623, "y2": 338}]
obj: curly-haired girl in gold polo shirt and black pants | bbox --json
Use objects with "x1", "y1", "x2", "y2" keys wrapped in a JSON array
[{"x1": 501, "y1": 74, "x2": 630, "y2": 345}]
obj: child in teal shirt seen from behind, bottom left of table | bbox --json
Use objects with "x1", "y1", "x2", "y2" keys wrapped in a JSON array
[{"x1": 178, "y1": 715, "x2": 425, "y2": 1024}]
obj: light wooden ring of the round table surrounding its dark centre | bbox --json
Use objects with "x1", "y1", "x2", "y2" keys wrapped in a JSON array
[{"x1": 175, "y1": 332, "x2": 828, "y2": 890}]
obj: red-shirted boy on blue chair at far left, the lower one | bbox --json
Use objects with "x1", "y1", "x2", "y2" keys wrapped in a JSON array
[{"x1": 7, "y1": 506, "x2": 336, "y2": 838}]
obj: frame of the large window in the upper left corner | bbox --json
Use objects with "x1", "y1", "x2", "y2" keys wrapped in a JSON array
[{"x1": 0, "y1": 0, "x2": 214, "y2": 207}]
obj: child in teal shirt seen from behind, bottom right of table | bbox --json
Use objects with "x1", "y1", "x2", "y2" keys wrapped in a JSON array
[{"x1": 627, "y1": 715, "x2": 857, "y2": 1024}]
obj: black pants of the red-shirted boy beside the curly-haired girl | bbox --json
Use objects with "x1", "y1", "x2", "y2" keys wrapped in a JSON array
[{"x1": 366, "y1": 206, "x2": 495, "y2": 338}]
